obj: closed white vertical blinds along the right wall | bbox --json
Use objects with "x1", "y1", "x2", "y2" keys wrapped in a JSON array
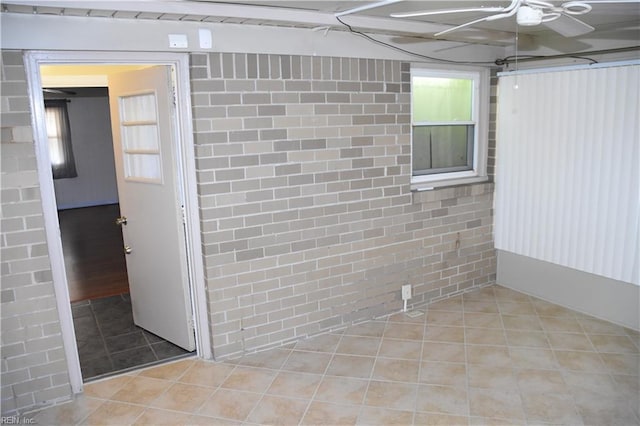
[{"x1": 495, "y1": 65, "x2": 640, "y2": 284}]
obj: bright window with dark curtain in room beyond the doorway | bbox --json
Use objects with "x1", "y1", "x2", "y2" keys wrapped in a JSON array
[{"x1": 44, "y1": 99, "x2": 78, "y2": 179}]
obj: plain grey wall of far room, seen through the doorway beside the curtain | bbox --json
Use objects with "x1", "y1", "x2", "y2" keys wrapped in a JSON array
[{"x1": 54, "y1": 97, "x2": 118, "y2": 209}]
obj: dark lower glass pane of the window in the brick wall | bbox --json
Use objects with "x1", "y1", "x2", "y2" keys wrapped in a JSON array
[{"x1": 412, "y1": 125, "x2": 474, "y2": 175}]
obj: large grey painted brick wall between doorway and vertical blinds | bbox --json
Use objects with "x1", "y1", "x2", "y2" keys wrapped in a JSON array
[{"x1": 191, "y1": 53, "x2": 495, "y2": 357}]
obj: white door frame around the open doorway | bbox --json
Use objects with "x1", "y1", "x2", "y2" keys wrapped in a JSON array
[{"x1": 24, "y1": 51, "x2": 213, "y2": 393}]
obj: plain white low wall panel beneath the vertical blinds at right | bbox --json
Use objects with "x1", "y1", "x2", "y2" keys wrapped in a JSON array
[{"x1": 496, "y1": 250, "x2": 640, "y2": 330}]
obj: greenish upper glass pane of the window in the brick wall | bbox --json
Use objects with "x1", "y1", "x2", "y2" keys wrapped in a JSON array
[{"x1": 411, "y1": 76, "x2": 473, "y2": 122}]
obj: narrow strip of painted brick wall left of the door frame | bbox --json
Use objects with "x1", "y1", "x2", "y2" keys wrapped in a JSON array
[{"x1": 0, "y1": 51, "x2": 71, "y2": 416}]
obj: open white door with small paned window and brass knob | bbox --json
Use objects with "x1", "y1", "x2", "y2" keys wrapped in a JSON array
[{"x1": 109, "y1": 65, "x2": 195, "y2": 351}]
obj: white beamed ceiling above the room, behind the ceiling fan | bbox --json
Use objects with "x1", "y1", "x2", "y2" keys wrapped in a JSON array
[{"x1": 1, "y1": 0, "x2": 640, "y2": 51}]
